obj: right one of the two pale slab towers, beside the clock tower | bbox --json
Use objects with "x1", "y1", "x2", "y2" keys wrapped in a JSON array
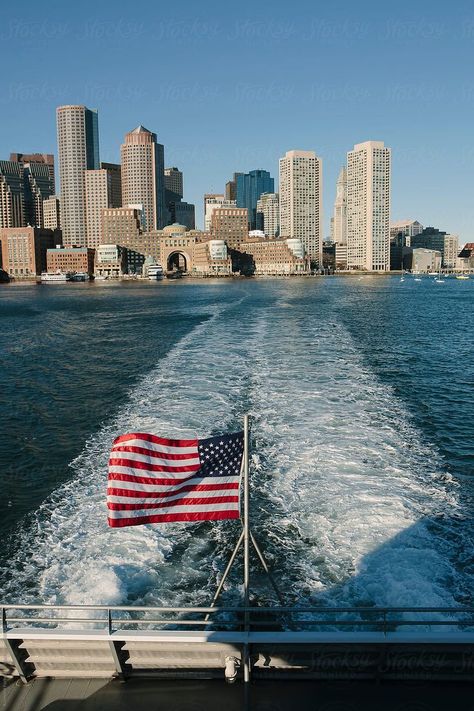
[{"x1": 347, "y1": 141, "x2": 391, "y2": 271}]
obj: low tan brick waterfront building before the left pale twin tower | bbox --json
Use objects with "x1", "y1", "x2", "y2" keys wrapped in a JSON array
[{"x1": 240, "y1": 237, "x2": 310, "y2": 276}]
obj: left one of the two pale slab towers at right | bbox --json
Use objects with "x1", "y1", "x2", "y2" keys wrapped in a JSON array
[{"x1": 280, "y1": 151, "x2": 323, "y2": 265}]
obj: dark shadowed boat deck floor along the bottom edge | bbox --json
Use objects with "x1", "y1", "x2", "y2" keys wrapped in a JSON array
[{"x1": 0, "y1": 679, "x2": 472, "y2": 711}]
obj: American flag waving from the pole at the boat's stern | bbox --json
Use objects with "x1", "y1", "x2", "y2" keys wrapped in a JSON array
[{"x1": 107, "y1": 432, "x2": 244, "y2": 527}]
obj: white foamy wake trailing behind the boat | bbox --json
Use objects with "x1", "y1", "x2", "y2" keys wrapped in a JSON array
[{"x1": 2, "y1": 285, "x2": 457, "y2": 606}]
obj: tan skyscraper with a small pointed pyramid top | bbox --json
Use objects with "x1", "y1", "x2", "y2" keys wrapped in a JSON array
[{"x1": 120, "y1": 126, "x2": 166, "y2": 231}]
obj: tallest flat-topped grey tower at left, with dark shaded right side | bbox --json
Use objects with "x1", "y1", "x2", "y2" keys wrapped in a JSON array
[{"x1": 56, "y1": 105, "x2": 99, "y2": 247}]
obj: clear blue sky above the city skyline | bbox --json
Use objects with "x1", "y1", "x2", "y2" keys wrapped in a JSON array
[{"x1": 0, "y1": 0, "x2": 474, "y2": 241}]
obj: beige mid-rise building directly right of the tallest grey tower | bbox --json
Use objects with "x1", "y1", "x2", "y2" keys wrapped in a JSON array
[{"x1": 84, "y1": 163, "x2": 122, "y2": 249}]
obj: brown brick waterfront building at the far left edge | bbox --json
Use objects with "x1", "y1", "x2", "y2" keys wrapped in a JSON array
[{"x1": 0, "y1": 226, "x2": 62, "y2": 278}]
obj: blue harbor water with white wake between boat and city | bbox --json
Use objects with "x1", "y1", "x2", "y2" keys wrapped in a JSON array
[{"x1": 0, "y1": 277, "x2": 474, "y2": 605}]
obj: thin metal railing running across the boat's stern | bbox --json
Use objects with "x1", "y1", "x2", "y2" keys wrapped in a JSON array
[{"x1": 0, "y1": 604, "x2": 474, "y2": 635}]
